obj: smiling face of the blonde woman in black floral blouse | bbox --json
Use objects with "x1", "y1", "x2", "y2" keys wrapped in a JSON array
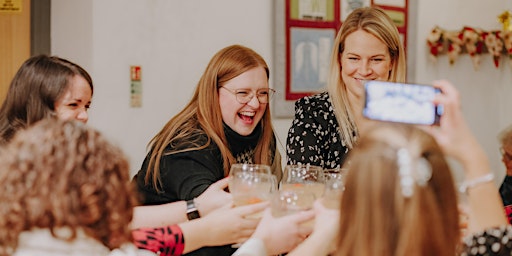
[{"x1": 340, "y1": 30, "x2": 393, "y2": 104}]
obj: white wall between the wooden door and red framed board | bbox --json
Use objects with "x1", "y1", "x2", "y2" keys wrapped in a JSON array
[{"x1": 52, "y1": 0, "x2": 272, "y2": 172}]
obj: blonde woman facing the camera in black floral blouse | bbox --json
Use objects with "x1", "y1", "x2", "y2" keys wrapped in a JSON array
[{"x1": 286, "y1": 7, "x2": 406, "y2": 168}]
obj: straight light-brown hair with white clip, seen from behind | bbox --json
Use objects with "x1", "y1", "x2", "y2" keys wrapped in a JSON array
[{"x1": 335, "y1": 124, "x2": 460, "y2": 256}]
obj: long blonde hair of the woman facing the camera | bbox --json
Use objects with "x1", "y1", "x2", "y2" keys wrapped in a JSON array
[{"x1": 327, "y1": 7, "x2": 406, "y2": 148}]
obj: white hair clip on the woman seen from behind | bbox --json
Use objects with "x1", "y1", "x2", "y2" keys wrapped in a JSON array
[{"x1": 397, "y1": 148, "x2": 432, "y2": 197}]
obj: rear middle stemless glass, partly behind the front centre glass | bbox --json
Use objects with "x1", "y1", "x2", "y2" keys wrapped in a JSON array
[{"x1": 280, "y1": 164, "x2": 325, "y2": 198}]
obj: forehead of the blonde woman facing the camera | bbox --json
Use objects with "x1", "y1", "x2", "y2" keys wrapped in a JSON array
[{"x1": 343, "y1": 30, "x2": 389, "y2": 56}]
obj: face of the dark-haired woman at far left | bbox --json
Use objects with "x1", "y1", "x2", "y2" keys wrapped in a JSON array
[{"x1": 55, "y1": 75, "x2": 92, "y2": 123}]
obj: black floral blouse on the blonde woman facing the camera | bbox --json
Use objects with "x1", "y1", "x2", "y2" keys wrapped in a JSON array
[{"x1": 286, "y1": 92, "x2": 349, "y2": 168}]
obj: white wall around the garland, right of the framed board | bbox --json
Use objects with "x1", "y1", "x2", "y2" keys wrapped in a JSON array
[{"x1": 415, "y1": 0, "x2": 512, "y2": 183}]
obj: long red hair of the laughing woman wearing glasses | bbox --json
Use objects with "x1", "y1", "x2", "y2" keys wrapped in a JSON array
[{"x1": 144, "y1": 45, "x2": 278, "y2": 191}]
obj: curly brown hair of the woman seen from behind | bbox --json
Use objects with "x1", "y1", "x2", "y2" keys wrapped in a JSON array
[{"x1": 0, "y1": 118, "x2": 137, "y2": 255}]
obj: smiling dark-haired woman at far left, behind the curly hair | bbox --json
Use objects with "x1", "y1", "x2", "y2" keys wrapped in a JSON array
[{"x1": 0, "y1": 55, "x2": 93, "y2": 144}]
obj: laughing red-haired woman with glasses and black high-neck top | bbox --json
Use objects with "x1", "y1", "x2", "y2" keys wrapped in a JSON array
[{"x1": 133, "y1": 45, "x2": 282, "y2": 256}]
